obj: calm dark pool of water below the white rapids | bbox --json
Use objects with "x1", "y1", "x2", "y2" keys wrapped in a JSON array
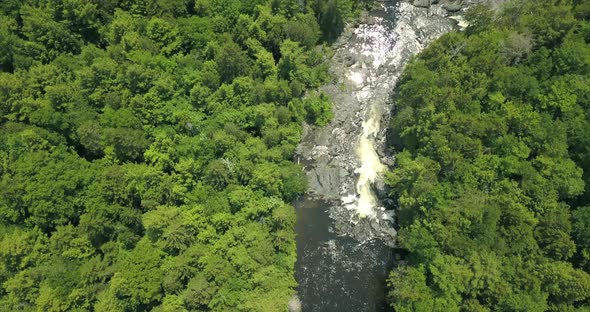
[{"x1": 295, "y1": 198, "x2": 393, "y2": 312}]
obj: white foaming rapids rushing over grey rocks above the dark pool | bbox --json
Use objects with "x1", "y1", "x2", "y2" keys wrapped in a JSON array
[{"x1": 341, "y1": 2, "x2": 462, "y2": 218}]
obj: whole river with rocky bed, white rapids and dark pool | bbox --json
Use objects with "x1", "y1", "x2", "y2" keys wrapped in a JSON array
[{"x1": 294, "y1": 0, "x2": 467, "y2": 312}]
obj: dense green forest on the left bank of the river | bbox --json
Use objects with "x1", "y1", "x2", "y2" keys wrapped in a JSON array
[{"x1": 0, "y1": 0, "x2": 370, "y2": 312}]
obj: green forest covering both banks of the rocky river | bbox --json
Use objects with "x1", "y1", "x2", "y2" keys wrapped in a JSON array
[{"x1": 0, "y1": 0, "x2": 590, "y2": 312}]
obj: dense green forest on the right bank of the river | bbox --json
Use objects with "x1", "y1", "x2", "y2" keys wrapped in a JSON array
[{"x1": 387, "y1": 0, "x2": 590, "y2": 312}]
